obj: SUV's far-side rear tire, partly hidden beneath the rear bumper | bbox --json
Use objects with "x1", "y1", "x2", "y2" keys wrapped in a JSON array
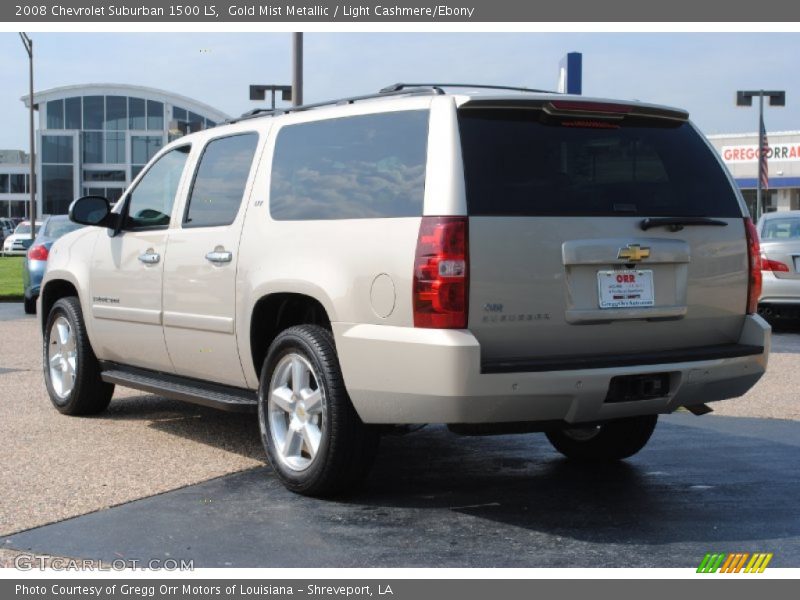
[{"x1": 547, "y1": 415, "x2": 658, "y2": 462}]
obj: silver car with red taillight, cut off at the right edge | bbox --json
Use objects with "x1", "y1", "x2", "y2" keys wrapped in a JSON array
[{"x1": 758, "y1": 210, "x2": 800, "y2": 320}]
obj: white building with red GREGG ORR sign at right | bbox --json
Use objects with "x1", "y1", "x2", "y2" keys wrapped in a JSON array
[{"x1": 708, "y1": 131, "x2": 800, "y2": 215}]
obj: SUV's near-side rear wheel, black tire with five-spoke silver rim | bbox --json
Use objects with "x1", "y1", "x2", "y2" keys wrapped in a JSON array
[{"x1": 258, "y1": 325, "x2": 379, "y2": 496}]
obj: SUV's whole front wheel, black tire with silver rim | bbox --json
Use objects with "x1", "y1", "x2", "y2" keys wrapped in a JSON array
[{"x1": 42, "y1": 296, "x2": 114, "y2": 416}]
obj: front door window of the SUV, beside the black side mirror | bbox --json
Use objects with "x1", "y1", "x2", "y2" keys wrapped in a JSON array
[{"x1": 124, "y1": 146, "x2": 189, "y2": 230}]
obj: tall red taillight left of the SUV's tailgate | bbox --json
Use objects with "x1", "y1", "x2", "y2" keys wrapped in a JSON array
[{"x1": 412, "y1": 217, "x2": 469, "y2": 329}]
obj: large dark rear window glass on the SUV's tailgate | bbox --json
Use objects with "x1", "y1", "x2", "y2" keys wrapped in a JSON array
[{"x1": 459, "y1": 109, "x2": 742, "y2": 217}]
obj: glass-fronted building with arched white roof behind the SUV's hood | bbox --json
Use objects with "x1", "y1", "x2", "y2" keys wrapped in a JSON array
[{"x1": 19, "y1": 84, "x2": 228, "y2": 216}]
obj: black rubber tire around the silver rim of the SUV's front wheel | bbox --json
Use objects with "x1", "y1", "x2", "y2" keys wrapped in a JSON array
[{"x1": 42, "y1": 296, "x2": 114, "y2": 416}]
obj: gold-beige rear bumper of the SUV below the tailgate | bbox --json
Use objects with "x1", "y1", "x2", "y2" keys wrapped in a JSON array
[{"x1": 333, "y1": 316, "x2": 770, "y2": 424}]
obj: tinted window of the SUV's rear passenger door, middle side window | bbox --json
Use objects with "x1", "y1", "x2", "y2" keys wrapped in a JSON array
[{"x1": 183, "y1": 133, "x2": 258, "y2": 227}]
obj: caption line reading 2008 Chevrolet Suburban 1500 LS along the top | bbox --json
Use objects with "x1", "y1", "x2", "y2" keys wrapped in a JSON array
[{"x1": 14, "y1": 3, "x2": 475, "y2": 19}]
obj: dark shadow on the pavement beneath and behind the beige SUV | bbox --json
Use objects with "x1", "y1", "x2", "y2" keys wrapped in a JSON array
[{"x1": 87, "y1": 395, "x2": 800, "y2": 544}]
